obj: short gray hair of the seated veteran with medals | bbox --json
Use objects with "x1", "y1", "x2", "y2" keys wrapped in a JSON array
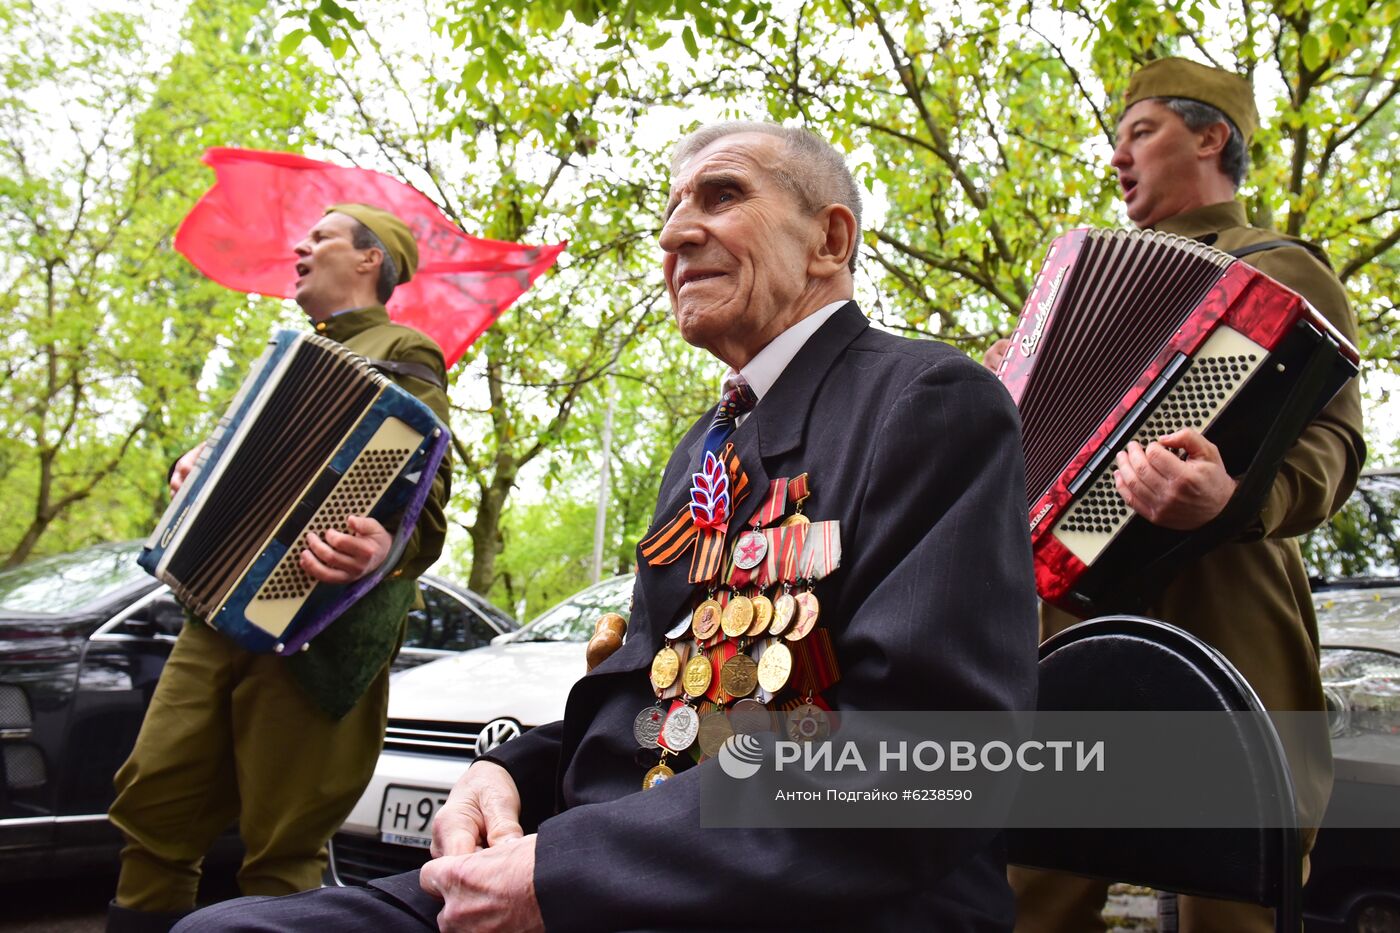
[{"x1": 671, "y1": 120, "x2": 861, "y2": 272}]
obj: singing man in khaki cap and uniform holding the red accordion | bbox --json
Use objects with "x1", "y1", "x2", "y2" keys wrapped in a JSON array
[{"x1": 987, "y1": 59, "x2": 1366, "y2": 933}]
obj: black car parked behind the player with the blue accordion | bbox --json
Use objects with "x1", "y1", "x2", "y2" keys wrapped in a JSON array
[{"x1": 0, "y1": 542, "x2": 519, "y2": 881}]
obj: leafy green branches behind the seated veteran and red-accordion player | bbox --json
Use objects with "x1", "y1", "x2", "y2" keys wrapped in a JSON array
[{"x1": 278, "y1": 0, "x2": 1400, "y2": 591}]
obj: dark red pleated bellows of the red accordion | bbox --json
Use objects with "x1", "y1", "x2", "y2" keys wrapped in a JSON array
[{"x1": 1019, "y1": 230, "x2": 1233, "y2": 507}]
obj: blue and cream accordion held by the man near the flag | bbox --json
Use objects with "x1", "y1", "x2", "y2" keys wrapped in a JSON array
[{"x1": 140, "y1": 331, "x2": 449, "y2": 653}]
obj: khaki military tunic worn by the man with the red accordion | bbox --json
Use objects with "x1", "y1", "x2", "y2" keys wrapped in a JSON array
[{"x1": 1042, "y1": 202, "x2": 1366, "y2": 825}]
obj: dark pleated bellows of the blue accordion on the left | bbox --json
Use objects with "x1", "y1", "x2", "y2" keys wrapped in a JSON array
[{"x1": 168, "y1": 336, "x2": 385, "y2": 616}]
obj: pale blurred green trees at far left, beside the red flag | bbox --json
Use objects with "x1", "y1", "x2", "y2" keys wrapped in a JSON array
[{"x1": 0, "y1": 0, "x2": 322, "y2": 565}]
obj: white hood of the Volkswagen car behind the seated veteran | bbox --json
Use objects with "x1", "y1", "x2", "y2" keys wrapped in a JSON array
[{"x1": 389, "y1": 642, "x2": 588, "y2": 726}]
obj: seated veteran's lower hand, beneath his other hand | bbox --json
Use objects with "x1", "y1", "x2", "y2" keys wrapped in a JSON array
[{"x1": 419, "y1": 829, "x2": 545, "y2": 933}]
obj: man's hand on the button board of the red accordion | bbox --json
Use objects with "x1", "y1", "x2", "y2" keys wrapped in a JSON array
[{"x1": 1113, "y1": 427, "x2": 1236, "y2": 531}]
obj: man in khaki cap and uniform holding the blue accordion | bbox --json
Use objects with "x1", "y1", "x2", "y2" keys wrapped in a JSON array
[{"x1": 108, "y1": 205, "x2": 451, "y2": 932}]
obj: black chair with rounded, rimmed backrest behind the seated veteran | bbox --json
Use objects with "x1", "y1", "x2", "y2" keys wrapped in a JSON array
[{"x1": 1008, "y1": 616, "x2": 1302, "y2": 933}]
